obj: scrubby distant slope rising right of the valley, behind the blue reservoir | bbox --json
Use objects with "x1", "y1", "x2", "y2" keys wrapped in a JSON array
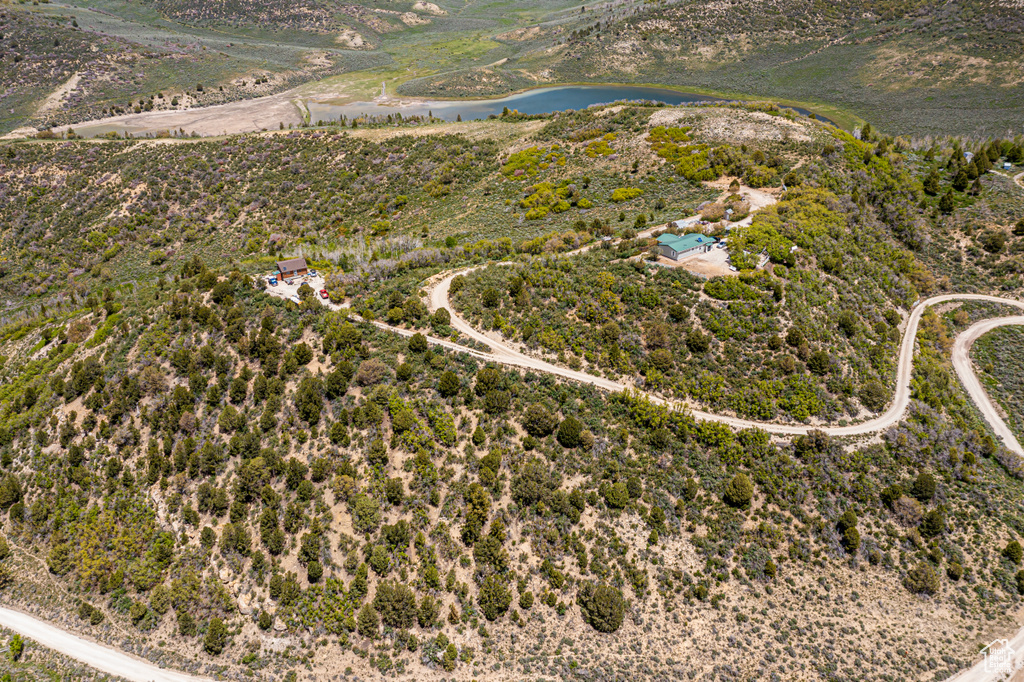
[{"x1": 401, "y1": 0, "x2": 1024, "y2": 134}]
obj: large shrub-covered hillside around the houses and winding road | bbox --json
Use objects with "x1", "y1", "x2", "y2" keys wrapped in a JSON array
[{"x1": 0, "y1": 105, "x2": 1024, "y2": 682}]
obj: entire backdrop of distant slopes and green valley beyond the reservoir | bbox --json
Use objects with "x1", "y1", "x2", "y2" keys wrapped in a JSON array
[{"x1": 0, "y1": 0, "x2": 1024, "y2": 135}]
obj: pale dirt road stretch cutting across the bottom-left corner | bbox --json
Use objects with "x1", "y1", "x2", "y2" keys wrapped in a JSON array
[{"x1": 0, "y1": 606, "x2": 212, "y2": 682}]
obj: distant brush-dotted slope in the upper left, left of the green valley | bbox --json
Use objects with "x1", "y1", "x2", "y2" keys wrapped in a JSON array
[{"x1": 0, "y1": 2, "x2": 389, "y2": 134}]
